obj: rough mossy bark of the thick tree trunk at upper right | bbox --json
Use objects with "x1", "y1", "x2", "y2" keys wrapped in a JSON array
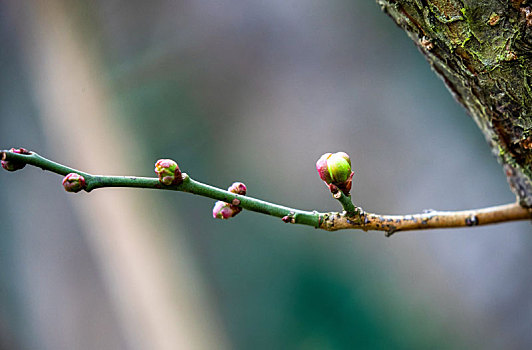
[{"x1": 377, "y1": 0, "x2": 532, "y2": 208}]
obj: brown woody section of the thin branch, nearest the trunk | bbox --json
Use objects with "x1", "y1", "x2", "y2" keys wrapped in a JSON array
[{"x1": 320, "y1": 203, "x2": 532, "y2": 236}]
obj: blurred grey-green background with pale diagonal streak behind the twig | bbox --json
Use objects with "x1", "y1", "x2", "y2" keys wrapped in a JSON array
[{"x1": 0, "y1": 0, "x2": 532, "y2": 349}]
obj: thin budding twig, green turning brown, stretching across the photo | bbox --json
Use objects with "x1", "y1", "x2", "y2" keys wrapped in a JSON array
[{"x1": 0, "y1": 148, "x2": 532, "y2": 236}]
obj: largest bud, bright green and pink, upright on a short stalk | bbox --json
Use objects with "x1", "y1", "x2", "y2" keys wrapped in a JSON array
[{"x1": 316, "y1": 152, "x2": 354, "y2": 195}]
